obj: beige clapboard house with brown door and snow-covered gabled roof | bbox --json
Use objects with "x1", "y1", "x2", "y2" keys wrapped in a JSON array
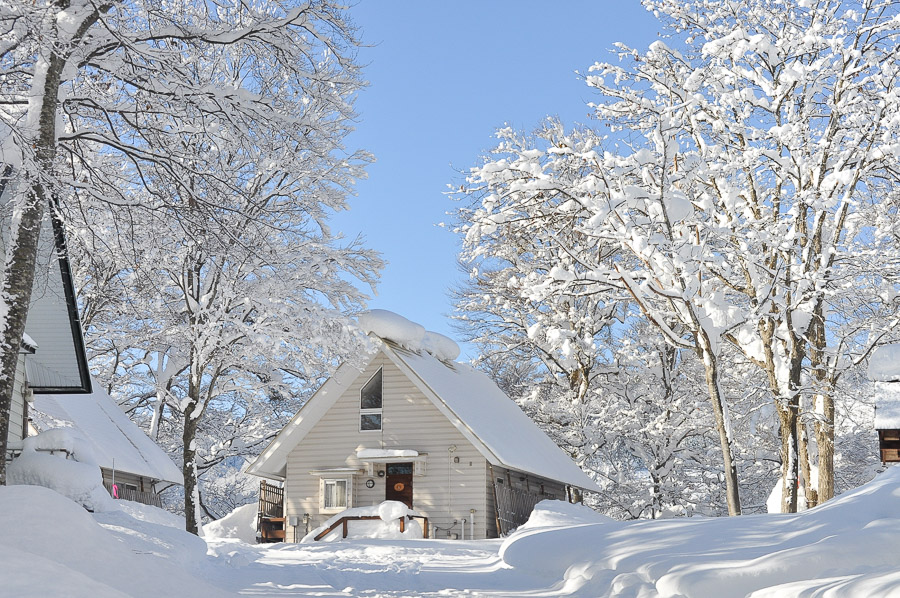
[{"x1": 247, "y1": 310, "x2": 599, "y2": 539}]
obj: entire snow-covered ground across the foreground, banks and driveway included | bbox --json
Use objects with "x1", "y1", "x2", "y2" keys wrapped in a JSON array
[{"x1": 0, "y1": 468, "x2": 900, "y2": 598}]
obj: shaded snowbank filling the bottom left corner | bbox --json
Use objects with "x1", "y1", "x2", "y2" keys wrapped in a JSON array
[{"x1": 0, "y1": 486, "x2": 230, "y2": 598}]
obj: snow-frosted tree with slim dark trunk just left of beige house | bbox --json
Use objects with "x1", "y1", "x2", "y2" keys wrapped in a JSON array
[{"x1": 70, "y1": 146, "x2": 380, "y2": 531}]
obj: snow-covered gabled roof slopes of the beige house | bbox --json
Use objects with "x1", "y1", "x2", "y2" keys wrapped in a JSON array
[{"x1": 247, "y1": 340, "x2": 600, "y2": 491}]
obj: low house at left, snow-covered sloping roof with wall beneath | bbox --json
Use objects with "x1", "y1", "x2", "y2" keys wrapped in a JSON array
[{"x1": 31, "y1": 385, "x2": 184, "y2": 504}]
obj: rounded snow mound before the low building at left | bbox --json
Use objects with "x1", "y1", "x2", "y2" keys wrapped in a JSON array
[{"x1": 6, "y1": 428, "x2": 115, "y2": 511}]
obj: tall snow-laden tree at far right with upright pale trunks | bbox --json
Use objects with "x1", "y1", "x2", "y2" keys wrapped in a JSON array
[{"x1": 588, "y1": 0, "x2": 900, "y2": 511}]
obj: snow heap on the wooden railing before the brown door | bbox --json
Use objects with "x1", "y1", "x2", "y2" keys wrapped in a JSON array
[{"x1": 300, "y1": 500, "x2": 423, "y2": 543}]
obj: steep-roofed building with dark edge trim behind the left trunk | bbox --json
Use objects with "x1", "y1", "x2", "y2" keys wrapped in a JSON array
[{"x1": 0, "y1": 188, "x2": 91, "y2": 458}]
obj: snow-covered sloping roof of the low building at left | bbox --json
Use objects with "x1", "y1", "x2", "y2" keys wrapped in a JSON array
[{"x1": 31, "y1": 384, "x2": 184, "y2": 484}]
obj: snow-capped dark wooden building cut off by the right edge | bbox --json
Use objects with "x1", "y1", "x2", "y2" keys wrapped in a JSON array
[{"x1": 869, "y1": 344, "x2": 900, "y2": 463}]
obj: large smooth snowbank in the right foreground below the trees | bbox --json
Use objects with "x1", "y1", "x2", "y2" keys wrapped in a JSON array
[{"x1": 500, "y1": 468, "x2": 900, "y2": 598}]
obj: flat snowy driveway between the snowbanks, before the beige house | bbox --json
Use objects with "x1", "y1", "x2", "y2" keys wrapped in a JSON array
[{"x1": 210, "y1": 540, "x2": 558, "y2": 597}]
